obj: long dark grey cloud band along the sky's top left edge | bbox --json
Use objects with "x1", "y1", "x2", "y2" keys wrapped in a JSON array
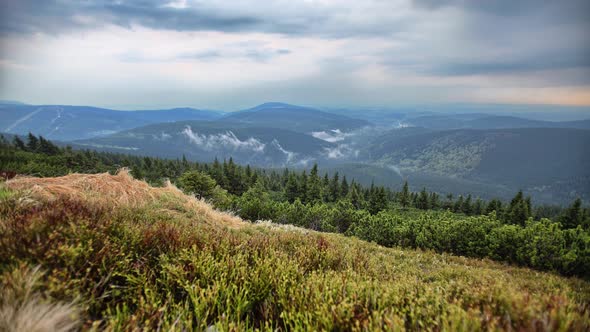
[{"x1": 0, "y1": 0, "x2": 408, "y2": 37}]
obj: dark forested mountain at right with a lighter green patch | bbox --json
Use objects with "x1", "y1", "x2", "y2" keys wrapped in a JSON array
[{"x1": 369, "y1": 128, "x2": 590, "y2": 200}]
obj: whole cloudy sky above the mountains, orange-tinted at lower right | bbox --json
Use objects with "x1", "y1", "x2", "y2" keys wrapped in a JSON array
[{"x1": 0, "y1": 0, "x2": 590, "y2": 110}]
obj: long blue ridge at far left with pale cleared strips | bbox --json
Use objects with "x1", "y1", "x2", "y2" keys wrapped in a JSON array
[{"x1": 0, "y1": 104, "x2": 222, "y2": 140}]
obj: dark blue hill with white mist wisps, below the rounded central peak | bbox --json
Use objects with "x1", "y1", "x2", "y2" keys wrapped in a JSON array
[{"x1": 74, "y1": 121, "x2": 338, "y2": 167}]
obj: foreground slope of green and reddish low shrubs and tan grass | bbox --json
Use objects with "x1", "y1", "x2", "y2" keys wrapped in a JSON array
[{"x1": 0, "y1": 174, "x2": 590, "y2": 330}]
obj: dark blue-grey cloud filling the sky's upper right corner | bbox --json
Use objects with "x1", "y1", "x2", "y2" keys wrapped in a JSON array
[{"x1": 404, "y1": 0, "x2": 590, "y2": 77}]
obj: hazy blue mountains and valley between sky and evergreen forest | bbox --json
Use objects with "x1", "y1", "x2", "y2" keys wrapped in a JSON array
[{"x1": 0, "y1": 102, "x2": 590, "y2": 204}]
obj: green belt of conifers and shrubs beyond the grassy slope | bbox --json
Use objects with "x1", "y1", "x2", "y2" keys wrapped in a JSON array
[{"x1": 0, "y1": 135, "x2": 590, "y2": 278}]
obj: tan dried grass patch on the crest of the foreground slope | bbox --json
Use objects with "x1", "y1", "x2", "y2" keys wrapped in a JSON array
[{"x1": 6, "y1": 169, "x2": 246, "y2": 228}]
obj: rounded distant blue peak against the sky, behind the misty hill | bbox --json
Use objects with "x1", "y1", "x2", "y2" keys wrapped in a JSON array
[{"x1": 222, "y1": 103, "x2": 369, "y2": 133}]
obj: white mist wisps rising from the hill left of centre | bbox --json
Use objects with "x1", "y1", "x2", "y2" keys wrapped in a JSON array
[{"x1": 182, "y1": 126, "x2": 266, "y2": 153}]
